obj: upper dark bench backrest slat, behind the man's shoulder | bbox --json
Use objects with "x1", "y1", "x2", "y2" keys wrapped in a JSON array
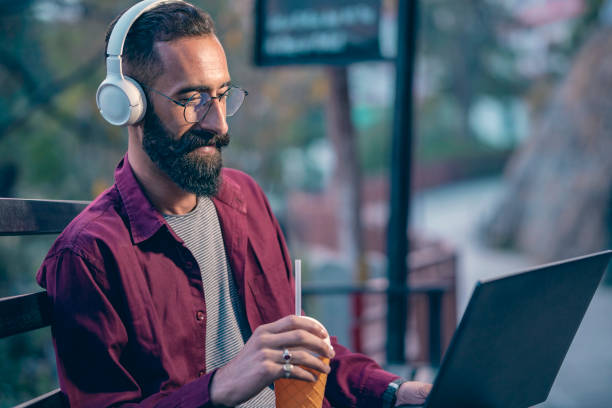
[{"x1": 0, "y1": 198, "x2": 89, "y2": 235}]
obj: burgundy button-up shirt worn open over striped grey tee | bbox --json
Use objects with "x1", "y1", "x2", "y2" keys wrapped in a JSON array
[{"x1": 37, "y1": 155, "x2": 397, "y2": 407}]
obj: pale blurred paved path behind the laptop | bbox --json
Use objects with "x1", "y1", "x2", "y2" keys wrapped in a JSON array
[{"x1": 412, "y1": 179, "x2": 612, "y2": 408}]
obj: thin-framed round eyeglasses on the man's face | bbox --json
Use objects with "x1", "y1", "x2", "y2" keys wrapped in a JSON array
[{"x1": 144, "y1": 85, "x2": 249, "y2": 123}]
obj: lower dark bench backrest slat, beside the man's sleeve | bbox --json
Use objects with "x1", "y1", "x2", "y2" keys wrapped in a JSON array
[{"x1": 0, "y1": 291, "x2": 51, "y2": 339}]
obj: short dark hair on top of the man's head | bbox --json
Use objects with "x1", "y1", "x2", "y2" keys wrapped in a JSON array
[{"x1": 105, "y1": 2, "x2": 215, "y2": 86}]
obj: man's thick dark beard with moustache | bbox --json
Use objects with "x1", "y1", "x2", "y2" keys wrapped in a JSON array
[{"x1": 142, "y1": 107, "x2": 230, "y2": 197}]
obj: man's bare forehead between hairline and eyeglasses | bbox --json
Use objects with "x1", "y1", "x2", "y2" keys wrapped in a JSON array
[{"x1": 155, "y1": 35, "x2": 230, "y2": 94}]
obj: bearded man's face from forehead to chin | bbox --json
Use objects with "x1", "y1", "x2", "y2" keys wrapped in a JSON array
[{"x1": 142, "y1": 35, "x2": 230, "y2": 196}]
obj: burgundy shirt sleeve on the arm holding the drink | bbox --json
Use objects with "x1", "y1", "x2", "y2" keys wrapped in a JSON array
[{"x1": 38, "y1": 250, "x2": 214, "y2": 407}]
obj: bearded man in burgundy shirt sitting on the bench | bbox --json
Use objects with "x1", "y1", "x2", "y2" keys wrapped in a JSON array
[{"x1": 37, "y1": 2, "x2": 429, "y2": 407}]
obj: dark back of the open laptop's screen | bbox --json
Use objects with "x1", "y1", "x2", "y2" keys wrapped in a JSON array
[{"x1": 404, "y1": 250, "x2": 612, "y2": 408}]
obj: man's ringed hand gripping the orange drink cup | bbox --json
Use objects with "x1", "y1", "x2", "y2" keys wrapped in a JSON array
[{"x1": 210, "y1": 315, "x2": 335, "y2": 407}]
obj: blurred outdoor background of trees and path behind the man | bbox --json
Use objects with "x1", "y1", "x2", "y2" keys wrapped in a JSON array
[{"x1": 0, "y1": 0, "x2": 612, "y2": 408}]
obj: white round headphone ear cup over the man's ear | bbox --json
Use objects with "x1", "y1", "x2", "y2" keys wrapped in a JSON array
[{"x1": 96, "y1": 75, "x2": 147, "y2": 126}]
